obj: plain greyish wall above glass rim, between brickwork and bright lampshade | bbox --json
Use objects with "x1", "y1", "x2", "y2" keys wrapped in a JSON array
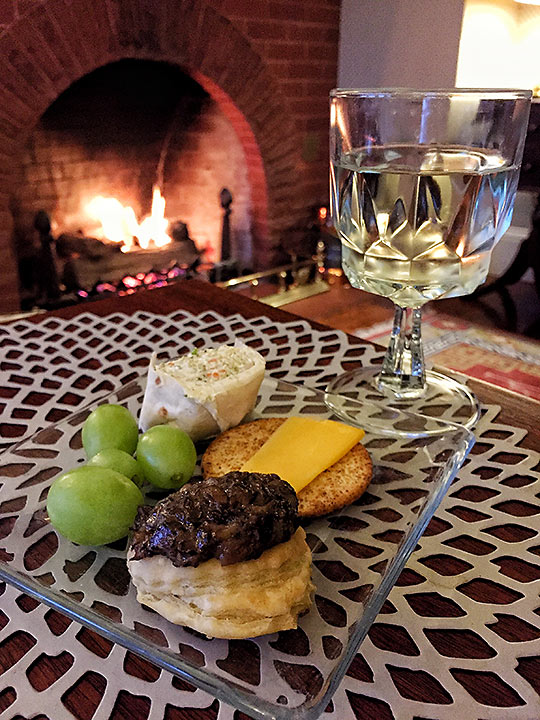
[{"x1": 338, "y1": 0, "x2": 464, "y2": 88}]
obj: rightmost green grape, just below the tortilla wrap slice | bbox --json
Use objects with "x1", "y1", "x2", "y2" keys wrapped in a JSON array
[{"x1": 137, "y1": 425, "x2": 197, "y2": 490}]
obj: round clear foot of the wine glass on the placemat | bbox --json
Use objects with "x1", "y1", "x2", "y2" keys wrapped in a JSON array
[{"x1": 325, "y1": 368, "x2": 481, "y2": 436}]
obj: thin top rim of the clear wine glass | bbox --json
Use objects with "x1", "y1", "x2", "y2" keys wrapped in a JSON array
[{"x1": 330, "y1": 87, "x2": 532, "y2": 100}]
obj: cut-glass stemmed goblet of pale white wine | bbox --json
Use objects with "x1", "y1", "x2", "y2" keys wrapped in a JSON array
[{"x1": 328, "y1": 88, "x2": 531, "y2": 427}]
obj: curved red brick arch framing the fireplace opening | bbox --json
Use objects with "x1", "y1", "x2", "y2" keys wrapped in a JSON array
[{"x1": 0, "y1": 0, "x2": 316, "y2": 311}]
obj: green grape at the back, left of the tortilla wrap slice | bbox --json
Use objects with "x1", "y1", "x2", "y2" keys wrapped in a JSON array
[{"x1": 82, "y1": 405, "x2": 139, "y2": 458}]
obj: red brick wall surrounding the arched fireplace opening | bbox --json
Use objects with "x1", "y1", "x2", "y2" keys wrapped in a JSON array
[{"x1": 0, "y1": 0, "x2": 340, "y2": 311}]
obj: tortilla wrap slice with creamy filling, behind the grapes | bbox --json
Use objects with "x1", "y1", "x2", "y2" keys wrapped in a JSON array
[{"x1": 139, "y1": 344, "x2": 265, "y2": 441}]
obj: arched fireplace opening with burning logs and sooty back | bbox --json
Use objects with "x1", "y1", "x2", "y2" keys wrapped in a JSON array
[{"x1": 11, "y1": 60, "x2": 254, "y2": 307}]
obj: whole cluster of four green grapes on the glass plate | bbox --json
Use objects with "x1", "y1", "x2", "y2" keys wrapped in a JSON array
[{"x1": 47, "y1": 405, "x2": 197, "y2": 545}]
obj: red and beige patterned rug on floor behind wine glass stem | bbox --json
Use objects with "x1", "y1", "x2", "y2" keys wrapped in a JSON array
[{"x1": 355, "y1": 310, "x2": 540, "y2": 400}]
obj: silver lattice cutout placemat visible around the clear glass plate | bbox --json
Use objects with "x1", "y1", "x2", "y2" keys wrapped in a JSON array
[{"x1": 0, "y1": 312, "x2": 540, "y2": 720}]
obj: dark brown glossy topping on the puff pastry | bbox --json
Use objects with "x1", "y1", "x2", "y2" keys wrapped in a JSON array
[{"x1": 131, "y1": 472, "x2": 299, "y2": 567}]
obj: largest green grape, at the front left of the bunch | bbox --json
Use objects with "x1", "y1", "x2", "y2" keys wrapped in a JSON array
[{"x1": 47, "y1": 465, "x2": 143, "y2": 545}]
